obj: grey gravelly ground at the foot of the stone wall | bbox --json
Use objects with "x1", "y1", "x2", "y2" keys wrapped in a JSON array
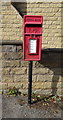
[{"x1": 2, "y1": 95, "x2": 63, "y2": 120}]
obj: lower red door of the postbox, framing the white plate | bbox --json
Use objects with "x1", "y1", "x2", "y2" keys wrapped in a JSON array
[{"x1": 23, "y1": 36, "x2": 42, "y2": 60}]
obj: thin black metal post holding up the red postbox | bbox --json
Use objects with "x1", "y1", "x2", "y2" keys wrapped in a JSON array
[{"x1": 28, "y1": 61, "x2": 32, "y2": 104}]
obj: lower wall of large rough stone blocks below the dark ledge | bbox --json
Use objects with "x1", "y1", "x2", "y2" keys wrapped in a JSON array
[{"x1": 0, "y1": 45, "x2": 63, "y2": 95}]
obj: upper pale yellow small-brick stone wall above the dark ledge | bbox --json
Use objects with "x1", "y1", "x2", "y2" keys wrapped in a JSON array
[{"x1": 0, "y1": 2, "x2": 63, "y2": 48}]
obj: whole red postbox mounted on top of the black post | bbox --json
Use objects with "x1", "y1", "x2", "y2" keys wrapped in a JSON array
[{"x1": 23, "y1": 15, "x2": 43, "y2": 61}]
